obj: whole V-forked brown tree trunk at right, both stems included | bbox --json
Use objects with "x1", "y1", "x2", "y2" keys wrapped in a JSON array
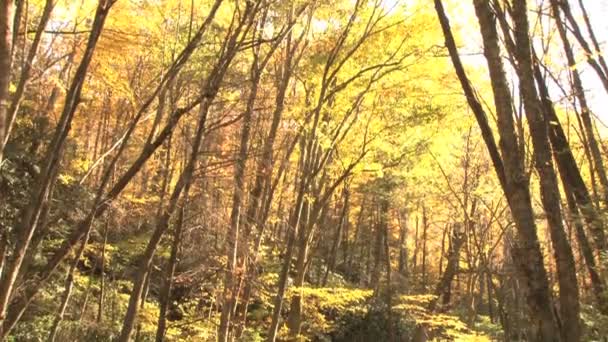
[{"x1": 435, "y1": 0, "x2": 560, "y2": 341}]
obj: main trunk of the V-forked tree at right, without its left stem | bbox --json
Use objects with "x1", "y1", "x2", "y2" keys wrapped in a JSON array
[{"x1": 474, "y1": 0, "x2": 560, "y2": 341}]
